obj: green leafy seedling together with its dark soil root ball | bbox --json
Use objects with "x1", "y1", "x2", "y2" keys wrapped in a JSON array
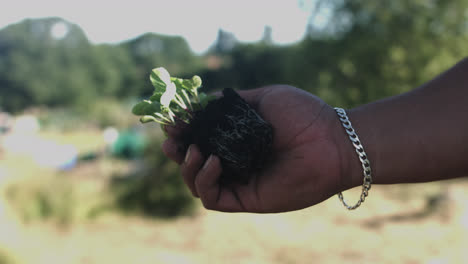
[{"x1": 132, "y1": 68, "x2": 273, "y2": 184}]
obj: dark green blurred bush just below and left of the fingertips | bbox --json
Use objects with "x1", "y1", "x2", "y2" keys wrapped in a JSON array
[{"x1": 111, "y1": 135, "x2": 195, "y2": 217}]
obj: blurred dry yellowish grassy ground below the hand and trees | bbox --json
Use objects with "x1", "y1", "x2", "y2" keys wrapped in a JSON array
[{"x1": 0, "y1": 129, "x2": 468, "y2": 264}]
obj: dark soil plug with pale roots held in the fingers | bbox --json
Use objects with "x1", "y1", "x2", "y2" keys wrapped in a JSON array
[{"x1": 183, "y1": 89, "x2": 273, "y2": 184}]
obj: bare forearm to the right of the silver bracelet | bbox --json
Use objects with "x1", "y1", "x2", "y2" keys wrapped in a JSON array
[{"x1": 348, "y1": 59, "x2": 468, "y2": 185}]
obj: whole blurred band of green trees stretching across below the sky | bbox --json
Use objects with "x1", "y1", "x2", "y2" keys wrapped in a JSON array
[{"x1": 0, "y1": 0, "x2": 468, "y2": 112}]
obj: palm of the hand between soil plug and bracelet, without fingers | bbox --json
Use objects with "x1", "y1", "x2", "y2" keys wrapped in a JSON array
[{"x1": 220, "y1": 86, "x2": 340, "y2": 212}]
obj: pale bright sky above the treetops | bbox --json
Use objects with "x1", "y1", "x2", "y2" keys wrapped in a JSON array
[{"x1": 0, "y1": 0, "x2": 311, "y2": 53}]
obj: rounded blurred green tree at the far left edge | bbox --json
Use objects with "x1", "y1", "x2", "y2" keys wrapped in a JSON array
[{"x1": 0, "y1": 18, "x2": 92, "y2": 111}]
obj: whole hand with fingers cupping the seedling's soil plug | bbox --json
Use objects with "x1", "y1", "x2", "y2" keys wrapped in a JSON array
[{"x1": 163, "y1": 85, "x2": 352, "y2": 213}]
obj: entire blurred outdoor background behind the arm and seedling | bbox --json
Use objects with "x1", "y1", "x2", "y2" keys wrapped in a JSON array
[{"x1": 0, "y1": 0, "x2": 468, "y2": 264}]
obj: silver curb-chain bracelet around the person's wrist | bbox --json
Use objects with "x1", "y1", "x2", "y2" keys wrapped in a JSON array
[{"x1": 335, "y1": 107, "x2": 372, "y2": 210}]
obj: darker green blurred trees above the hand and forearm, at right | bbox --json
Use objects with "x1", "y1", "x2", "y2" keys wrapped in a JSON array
[{"x1": 200, "y1": 0, "x2": 468, "y2": 107}]
